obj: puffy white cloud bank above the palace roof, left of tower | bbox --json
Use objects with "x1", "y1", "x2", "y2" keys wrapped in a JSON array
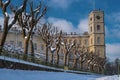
[{"x1": 48, "y1": 17, "x2": 88, "y2": 33}]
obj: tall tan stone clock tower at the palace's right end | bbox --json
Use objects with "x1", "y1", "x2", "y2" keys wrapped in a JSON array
[{"x1": 89, "y1": 10, "x2": 105, "y2": 58}]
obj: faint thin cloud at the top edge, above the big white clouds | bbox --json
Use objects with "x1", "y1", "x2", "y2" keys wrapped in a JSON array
[{"x1": 48, "y1": 0, "x2": 78, "y2": 9}]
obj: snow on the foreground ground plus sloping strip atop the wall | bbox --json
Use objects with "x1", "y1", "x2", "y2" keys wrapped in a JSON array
[{"x1": 0, "y1": 56, "x2": 120, "y2": 80}]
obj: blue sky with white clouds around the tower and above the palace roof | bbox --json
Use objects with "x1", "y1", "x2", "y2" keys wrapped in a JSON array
[{"x1": 0, "y1": 0, "x2": 120, "y2": 60}]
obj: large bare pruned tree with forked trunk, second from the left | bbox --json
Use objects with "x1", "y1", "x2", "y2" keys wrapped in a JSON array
[{"x1": 18, "y1": 2, "x2": 47, "y2": 60}]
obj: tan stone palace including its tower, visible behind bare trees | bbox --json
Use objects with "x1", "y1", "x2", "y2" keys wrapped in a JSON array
[{"x1": 0, "y1": 10, "x2": 106, "y2": 64}]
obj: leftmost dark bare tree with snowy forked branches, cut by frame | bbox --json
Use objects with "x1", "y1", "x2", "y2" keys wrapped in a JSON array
[{"x1": 0, "y1": 0, "x2": 27, "y2": 54}]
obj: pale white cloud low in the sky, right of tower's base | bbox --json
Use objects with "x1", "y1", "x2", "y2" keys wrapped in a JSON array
[{"x1": 106, "y1": 43, "x2": 120, "y2": 61}]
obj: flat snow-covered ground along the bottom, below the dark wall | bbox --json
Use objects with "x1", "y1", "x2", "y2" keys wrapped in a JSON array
[{"x1": 0, "y1": 69, "x2": 120, "y2": 80}]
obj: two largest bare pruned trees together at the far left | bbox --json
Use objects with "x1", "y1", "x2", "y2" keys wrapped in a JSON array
[{"x1": 0, "y1": 0, "x2": 47, "y2": 60}]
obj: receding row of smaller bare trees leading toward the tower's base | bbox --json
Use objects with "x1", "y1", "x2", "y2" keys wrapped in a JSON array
[{"x1": 38, "y1": 24, "x2": 105, "y2": 72}]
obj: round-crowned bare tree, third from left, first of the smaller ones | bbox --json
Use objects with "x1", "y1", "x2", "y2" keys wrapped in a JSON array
[{"x1": 38, "y1": 23, "x2": 55, "y2": 64}]
